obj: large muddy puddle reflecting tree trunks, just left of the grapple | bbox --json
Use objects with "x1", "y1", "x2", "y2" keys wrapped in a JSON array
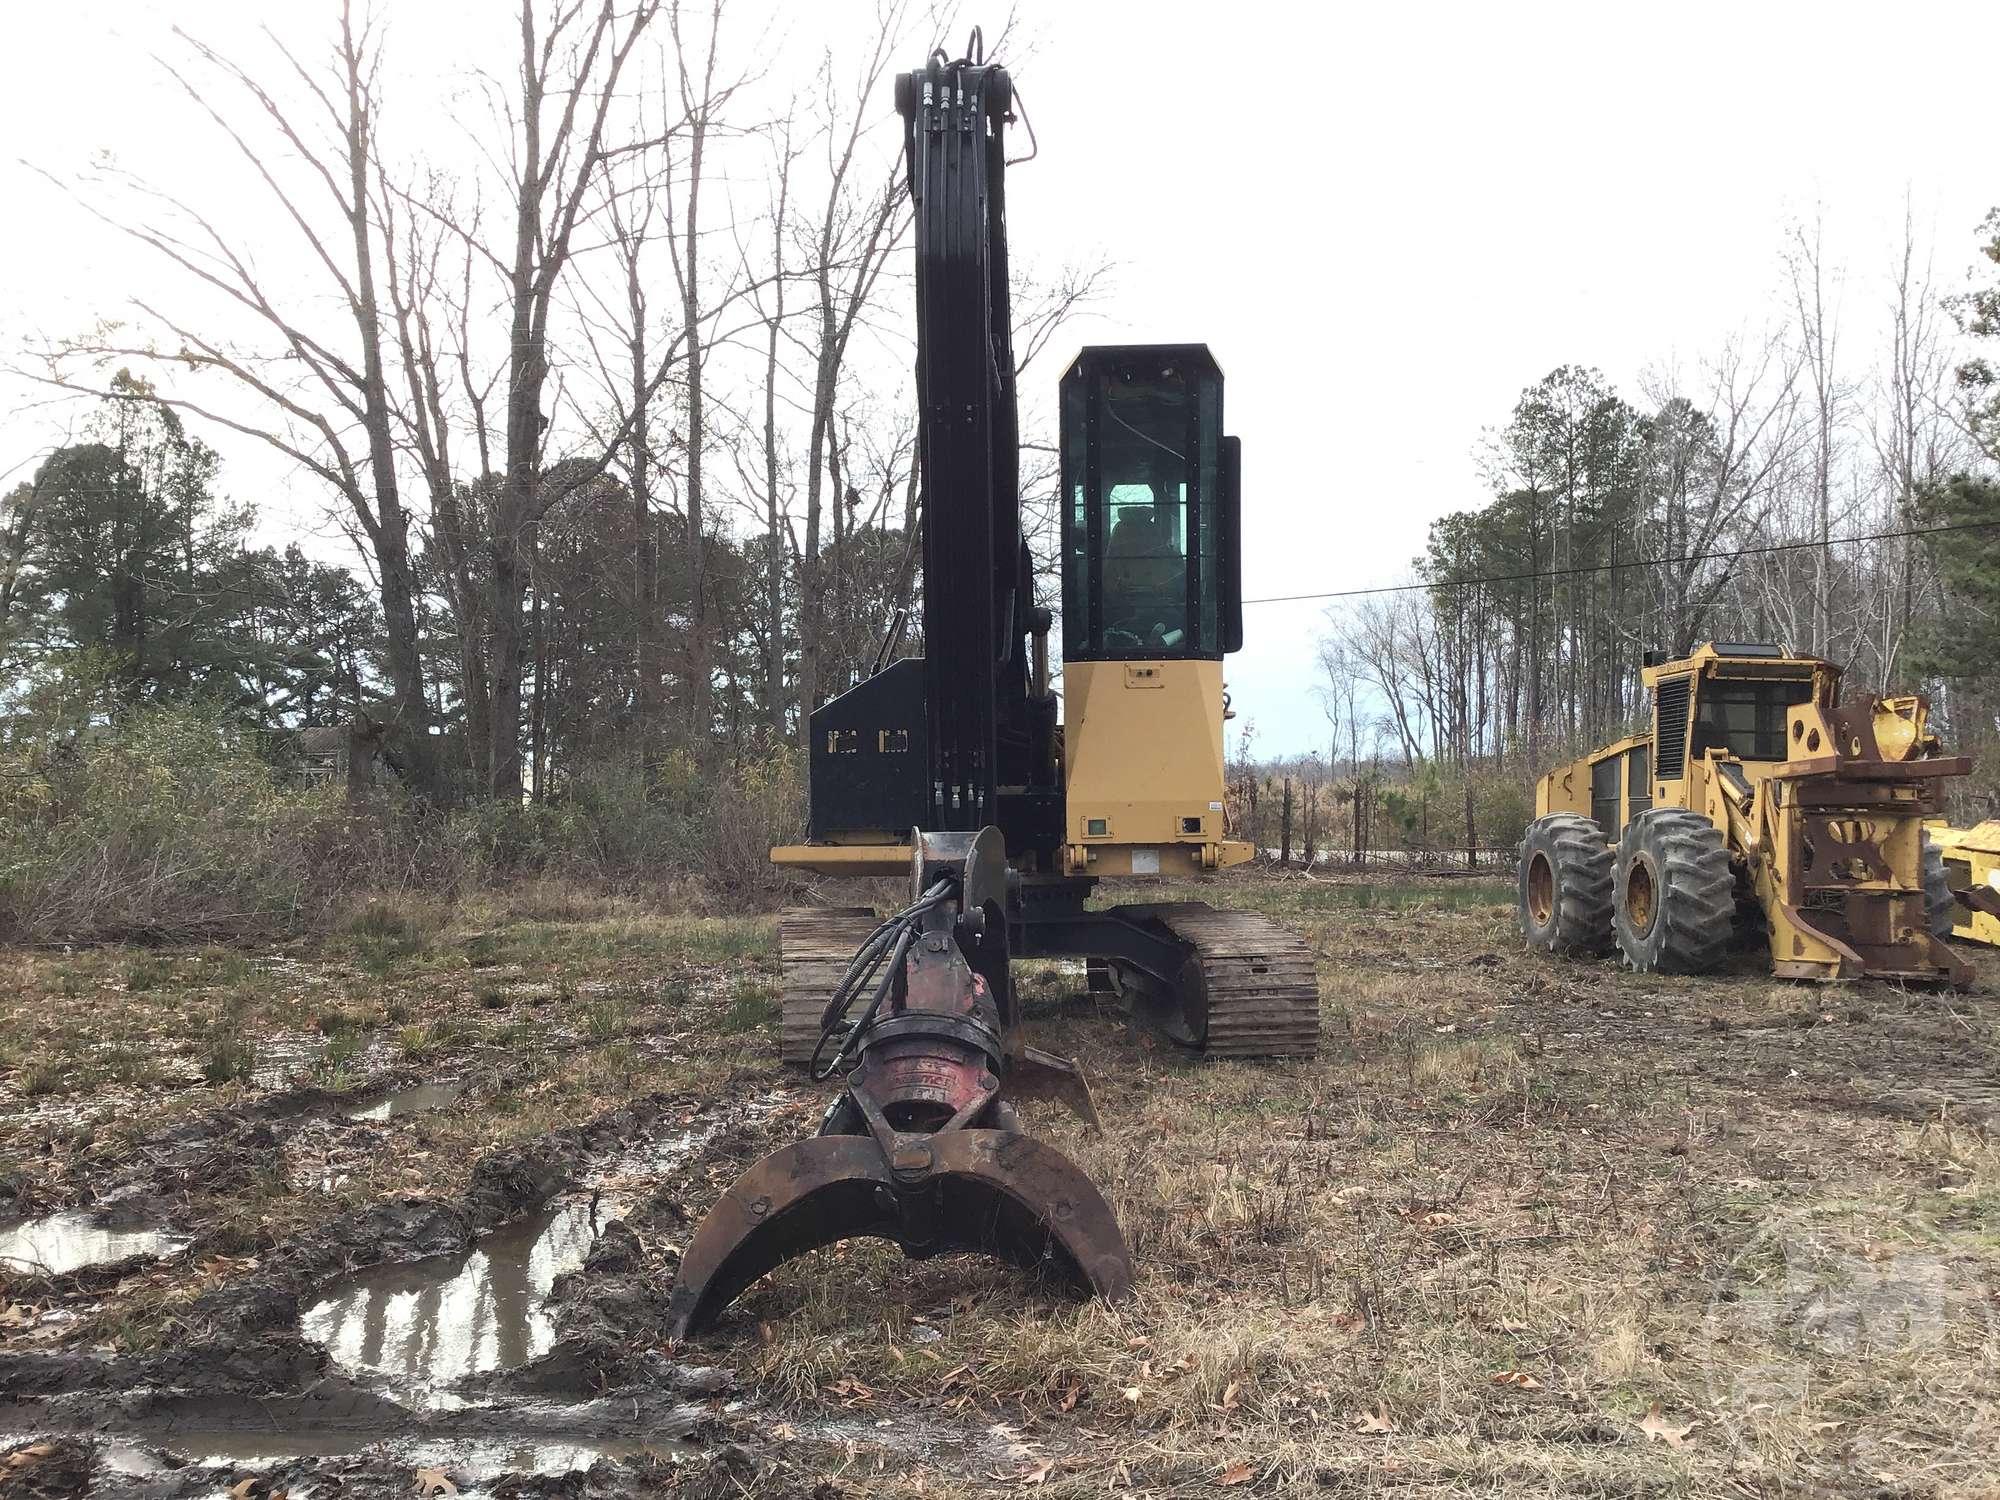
[{"x1": 300, "y1": 1194, "x2": 622, "y2": 1406}]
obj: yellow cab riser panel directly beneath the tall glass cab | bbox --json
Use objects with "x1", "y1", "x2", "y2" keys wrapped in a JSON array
[{"x1": 1062, "y1": 662, "x2": 1256, "y2": 876}]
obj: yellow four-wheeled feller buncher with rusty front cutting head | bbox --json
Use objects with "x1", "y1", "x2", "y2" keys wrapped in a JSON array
[{"x1": 1520, "y1": 642, "x2": 1972, "y2": 984}]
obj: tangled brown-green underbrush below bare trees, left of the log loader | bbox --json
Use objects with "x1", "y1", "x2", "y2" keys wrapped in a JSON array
[{"x1": 0, "y1": 706, "x2": 804, "y2": 940}]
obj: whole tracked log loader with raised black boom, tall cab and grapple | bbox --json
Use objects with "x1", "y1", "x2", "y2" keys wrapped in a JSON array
[{"x1": 670, "y1": 48, "x2": 1320, "y2": 1338}]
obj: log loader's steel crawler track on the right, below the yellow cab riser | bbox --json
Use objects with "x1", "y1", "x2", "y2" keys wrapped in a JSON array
[{"x1": 1158, "y1": 902, "x2": 1320, "y2": 1058}]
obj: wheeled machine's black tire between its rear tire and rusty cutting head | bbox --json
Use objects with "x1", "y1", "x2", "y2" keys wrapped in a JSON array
[{"x1": 1612, "y1": 808, "x2": 1736, "y2": 974}]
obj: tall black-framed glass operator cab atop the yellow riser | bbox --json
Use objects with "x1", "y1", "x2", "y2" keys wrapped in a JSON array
[{"x1": 1062, "y1": 344, "x2": 1242, "y2": 662}]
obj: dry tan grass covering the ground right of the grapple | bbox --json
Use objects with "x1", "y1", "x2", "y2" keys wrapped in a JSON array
[{"x1": 720, "y1": 888, "x2": 2000, "y2": 1494}]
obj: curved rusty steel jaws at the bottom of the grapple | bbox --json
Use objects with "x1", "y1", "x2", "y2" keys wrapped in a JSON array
[{"x1": 668, "y1": 1130, "x2": 1132, "y2": 1338}]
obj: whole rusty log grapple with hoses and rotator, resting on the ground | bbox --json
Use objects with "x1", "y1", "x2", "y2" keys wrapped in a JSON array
[{"x1": 668, "y1": 828, "x2": 1132, "y2": 1338}]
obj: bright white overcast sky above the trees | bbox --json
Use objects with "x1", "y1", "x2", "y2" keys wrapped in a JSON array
[{"x1": 0, "y1": 0, "x2": 2000, "y2": 754}]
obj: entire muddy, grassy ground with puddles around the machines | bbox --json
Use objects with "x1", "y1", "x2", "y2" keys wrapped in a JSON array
[{"x1": 0, "y1": 876, "x2": 2000, "y2": 1496}]
